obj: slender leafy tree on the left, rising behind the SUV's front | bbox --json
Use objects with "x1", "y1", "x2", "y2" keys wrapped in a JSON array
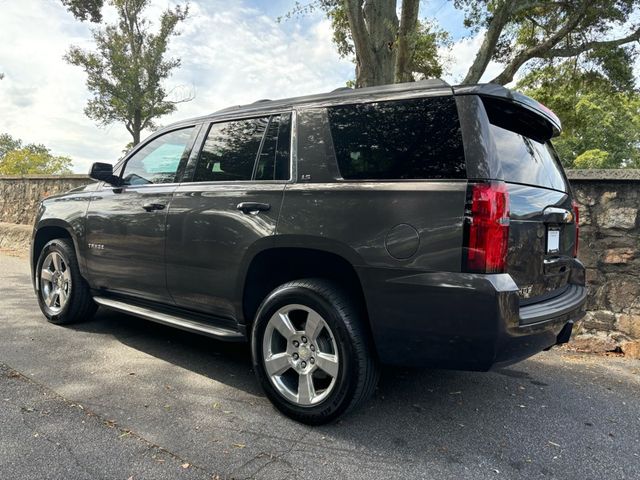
[{"x1": 65, "y1": 0, "x2": 192, "y2": 145}]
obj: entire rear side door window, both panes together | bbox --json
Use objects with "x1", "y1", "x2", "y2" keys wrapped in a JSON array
[{"x1": 193, "y1": 113, "x2": 291, "y2": 182}]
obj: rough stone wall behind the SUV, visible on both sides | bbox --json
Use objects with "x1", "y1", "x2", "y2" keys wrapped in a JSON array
[{"x1": 0, "y1": 170, "x2": 640, "y2": 350}]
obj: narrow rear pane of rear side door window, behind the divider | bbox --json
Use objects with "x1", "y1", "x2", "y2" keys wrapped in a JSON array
[{"x1": 255, "y1": 113, "x2": 291, "y2": 180}]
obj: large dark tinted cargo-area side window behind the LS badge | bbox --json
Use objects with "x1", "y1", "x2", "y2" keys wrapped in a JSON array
[{"x1": 329, "y1": 96, "x2": 466, "y2": 180}]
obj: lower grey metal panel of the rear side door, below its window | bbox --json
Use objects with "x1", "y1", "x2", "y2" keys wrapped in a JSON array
[{"x1": 166, "y1": 182, "x2": 284, "y2": 320}]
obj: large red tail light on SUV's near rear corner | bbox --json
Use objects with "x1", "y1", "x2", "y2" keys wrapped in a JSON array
[{"x1": 463, "y1": 182, "x2": 509, "y2": 273}]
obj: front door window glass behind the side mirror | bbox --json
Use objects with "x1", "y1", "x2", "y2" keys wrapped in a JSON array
[{"x1": 122, "y1": 127, "x2": 195, "y2": 185}]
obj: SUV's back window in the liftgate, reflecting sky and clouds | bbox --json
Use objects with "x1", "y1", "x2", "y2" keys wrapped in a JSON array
[{"x1": 484, "y1": 100, "x2": 567, "y2": 192}]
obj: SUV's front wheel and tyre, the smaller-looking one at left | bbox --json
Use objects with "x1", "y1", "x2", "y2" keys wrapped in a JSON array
[{"x1": 35, "y1": 238, "x2": 98, "y2": 325}]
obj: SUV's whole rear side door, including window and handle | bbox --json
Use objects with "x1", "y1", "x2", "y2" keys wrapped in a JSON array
[{"x1": 166, "y1": 112, "x2": 292, "y2": 323}]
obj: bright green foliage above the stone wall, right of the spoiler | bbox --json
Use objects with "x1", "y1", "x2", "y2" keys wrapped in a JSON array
[{"x1": 518, "y1": 60, "x2": 640, "y2": 168}]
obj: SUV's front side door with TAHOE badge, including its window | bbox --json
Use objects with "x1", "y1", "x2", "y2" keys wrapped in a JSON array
[{"x1": 86, "y1": 126, "x2": 197, "y2": 303}]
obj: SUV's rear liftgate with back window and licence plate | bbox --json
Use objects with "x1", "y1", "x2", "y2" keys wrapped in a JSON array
[{"x1": 483, "y1": 98, "x2": 578, "y2": 305}]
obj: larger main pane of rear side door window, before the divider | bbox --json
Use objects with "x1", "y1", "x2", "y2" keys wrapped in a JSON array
[{"x1": 194, "y1": 117, "x2": 269, "y2": 182}]
